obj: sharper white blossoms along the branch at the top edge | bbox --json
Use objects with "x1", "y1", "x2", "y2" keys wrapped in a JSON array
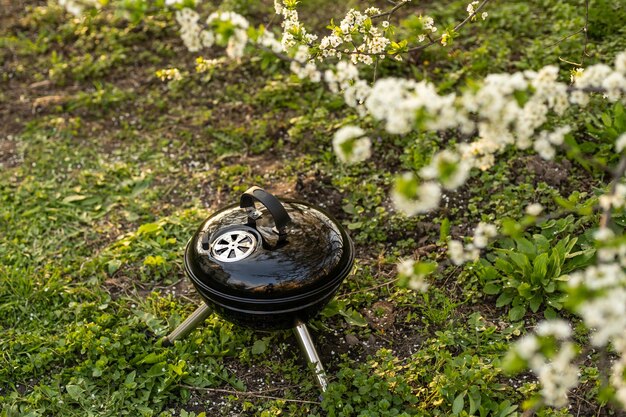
[{"x1": 168, "y1": 0, "x2": 446, "y2": 82}]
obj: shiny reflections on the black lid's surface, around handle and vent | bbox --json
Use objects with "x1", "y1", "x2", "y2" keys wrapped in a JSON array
[{"x1": 192, "y1": 202, "x2": 351, "y2": 298}]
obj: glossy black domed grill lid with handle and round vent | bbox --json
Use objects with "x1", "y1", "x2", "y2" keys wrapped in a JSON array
[{"x1": 185, "y1": 187, "x2": 354, "y2": 300}]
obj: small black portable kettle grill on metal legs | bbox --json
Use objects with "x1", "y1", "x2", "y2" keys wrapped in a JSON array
[{"x1": 163, "y1": 187, "x2": 354, "y2": 391}]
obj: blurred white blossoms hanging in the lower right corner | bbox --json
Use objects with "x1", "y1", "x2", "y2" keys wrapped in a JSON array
[{"x1": 515, "y1": 223, "x2": 626, "y2": 408}]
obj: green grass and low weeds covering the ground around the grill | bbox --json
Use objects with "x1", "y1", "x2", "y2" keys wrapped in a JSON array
[{"x1": 0, "y1": 0, "x2": 626, "y2": 417}]
